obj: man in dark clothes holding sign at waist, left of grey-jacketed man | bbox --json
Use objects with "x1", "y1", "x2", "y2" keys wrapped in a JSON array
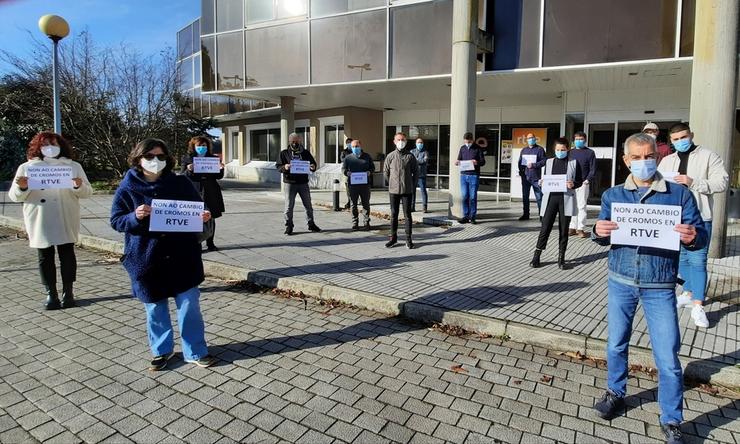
[{"x1": 342, "y1": 139, "x2": 375, "y2": 230}]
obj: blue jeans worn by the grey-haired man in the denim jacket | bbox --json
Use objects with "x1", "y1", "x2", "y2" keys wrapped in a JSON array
[{"x1": 606, "y1": 279, "x2": 683, "y2": 424}]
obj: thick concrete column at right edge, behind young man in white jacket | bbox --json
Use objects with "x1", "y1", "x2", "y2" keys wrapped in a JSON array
[{"x1": 689, "y1": 0, "x2": 738, "y2": 258}]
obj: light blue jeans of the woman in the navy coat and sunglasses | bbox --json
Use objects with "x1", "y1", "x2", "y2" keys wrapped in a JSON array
[{"x1": 144, "y1": 287, "x2": 208, "y2": 361}]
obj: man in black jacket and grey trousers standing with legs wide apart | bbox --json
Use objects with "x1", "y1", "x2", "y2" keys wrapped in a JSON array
[{"x1": 275, "y1": 133, "x2": 321, "y2": 236}]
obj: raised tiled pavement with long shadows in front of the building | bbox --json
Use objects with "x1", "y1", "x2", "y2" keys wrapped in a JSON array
[{"x1": 2, "y1": 188, "x2": 740, "y2": 380}]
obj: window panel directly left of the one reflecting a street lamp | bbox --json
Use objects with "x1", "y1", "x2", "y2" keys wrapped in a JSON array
[{"x1": 245, "y1": 22, "x2": 308, "y2": 88}]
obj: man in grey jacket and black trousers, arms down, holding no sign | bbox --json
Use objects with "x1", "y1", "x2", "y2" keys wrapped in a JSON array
[{"x1": 383, "y1": 133, "x2": 419, "y2": 250}]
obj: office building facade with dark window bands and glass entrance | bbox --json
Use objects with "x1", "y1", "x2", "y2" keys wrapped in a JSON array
[{"x1": 178, "y1": 0, "x2": 740, "y2": 203}]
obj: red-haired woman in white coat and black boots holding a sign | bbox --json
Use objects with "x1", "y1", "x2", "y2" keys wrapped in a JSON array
[{"x1": 8, "y1": 132, "x2": 92, "y2": 310}]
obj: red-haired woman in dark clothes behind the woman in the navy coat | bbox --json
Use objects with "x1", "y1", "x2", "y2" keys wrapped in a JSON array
[{"x1": 182, "y1": 136, "x2": 226, "y2": 251}]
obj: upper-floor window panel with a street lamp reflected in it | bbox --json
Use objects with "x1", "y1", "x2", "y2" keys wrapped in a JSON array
[{"x1": 311, "y1": 9, "x2": 387, "y2": 83}]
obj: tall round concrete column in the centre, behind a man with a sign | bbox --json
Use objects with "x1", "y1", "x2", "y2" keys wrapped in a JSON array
[{"x1": 448, "y1": 0, "x2": 478, "y2": 218}]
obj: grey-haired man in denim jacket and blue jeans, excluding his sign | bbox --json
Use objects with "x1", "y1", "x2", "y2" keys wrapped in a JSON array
[{"x1": 592, "y1": 133, "x2": 707, "y2": 443}]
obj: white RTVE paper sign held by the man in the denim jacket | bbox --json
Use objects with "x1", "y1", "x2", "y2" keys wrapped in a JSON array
[{"x1": 611, "y1": 203, "x2": 681, "y2": 251}]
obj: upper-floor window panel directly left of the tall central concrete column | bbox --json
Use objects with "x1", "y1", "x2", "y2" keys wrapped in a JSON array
[{"x1": 391, "y1": 0, "x2": 452, "y2": 78}]
